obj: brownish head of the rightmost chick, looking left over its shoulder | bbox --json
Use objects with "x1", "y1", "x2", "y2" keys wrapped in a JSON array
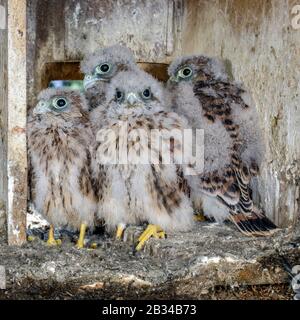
[{"x1": 168, "y1": 55, "x2": 228, "y2": 84}]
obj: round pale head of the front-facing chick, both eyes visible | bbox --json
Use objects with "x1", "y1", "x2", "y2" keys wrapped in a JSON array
[{"x1": 106, "y1": 70, "x2": 166, "y2": 116}]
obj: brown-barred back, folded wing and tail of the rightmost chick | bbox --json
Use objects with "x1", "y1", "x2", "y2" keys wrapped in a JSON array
[{"x1": 184, "y1": 80, "x2": 276, "y2": 235}]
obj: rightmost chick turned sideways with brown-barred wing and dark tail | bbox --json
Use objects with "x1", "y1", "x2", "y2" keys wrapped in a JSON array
[{"x1": 167, "y1": 55, "x2": 278, "y2": 236}]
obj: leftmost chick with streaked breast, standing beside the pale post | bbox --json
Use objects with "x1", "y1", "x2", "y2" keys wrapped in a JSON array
[{"x1": 28, "y1": 88, "x2": 97, "y2": 248}]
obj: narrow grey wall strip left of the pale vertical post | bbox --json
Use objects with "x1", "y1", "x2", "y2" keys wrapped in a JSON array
[{"x1": 0, "y1": 0, "x2": 7, "y2": 235}]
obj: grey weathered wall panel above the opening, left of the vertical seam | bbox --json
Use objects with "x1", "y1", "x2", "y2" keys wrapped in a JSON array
[{"x1": 28, "y1": 0, "x2": 182, "y2": 105}]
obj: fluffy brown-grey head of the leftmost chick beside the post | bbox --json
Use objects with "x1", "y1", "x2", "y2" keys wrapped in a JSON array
[{"x1": 32, "y1": 88, "x2": 88, "y2": 122}]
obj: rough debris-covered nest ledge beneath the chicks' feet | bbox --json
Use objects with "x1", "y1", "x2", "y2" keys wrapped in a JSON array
[{"x1": 0, "y1": 223, "x2": 300, "y2": 299}]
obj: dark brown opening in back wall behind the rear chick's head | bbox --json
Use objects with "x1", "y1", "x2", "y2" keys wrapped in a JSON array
[{"x1": 41, "y1": 61, "x2": 169, "y2": 89}]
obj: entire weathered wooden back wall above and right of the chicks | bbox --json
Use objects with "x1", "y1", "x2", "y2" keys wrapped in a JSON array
[{"x1": 27, "y1": 0, "x2": 300, "y2": 226}]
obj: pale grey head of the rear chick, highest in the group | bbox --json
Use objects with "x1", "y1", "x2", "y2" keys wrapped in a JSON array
[{"x1": 80, "y1": 45, "x2": 137, "y2": 90}]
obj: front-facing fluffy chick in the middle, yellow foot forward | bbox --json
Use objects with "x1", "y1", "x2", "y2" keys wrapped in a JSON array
[{"x1": 91, "y1": 70, "x2": 194, "y2": 251}]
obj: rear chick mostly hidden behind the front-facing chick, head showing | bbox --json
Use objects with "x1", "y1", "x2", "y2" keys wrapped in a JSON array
[{"x1": 80, "y1": 44, "x2": 138, "y2": 111}]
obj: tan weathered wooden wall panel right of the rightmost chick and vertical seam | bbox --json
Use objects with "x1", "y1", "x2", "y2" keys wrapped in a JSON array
[{"x1": 182, "y1": 0, "x2": 300, "y2": 226}]
